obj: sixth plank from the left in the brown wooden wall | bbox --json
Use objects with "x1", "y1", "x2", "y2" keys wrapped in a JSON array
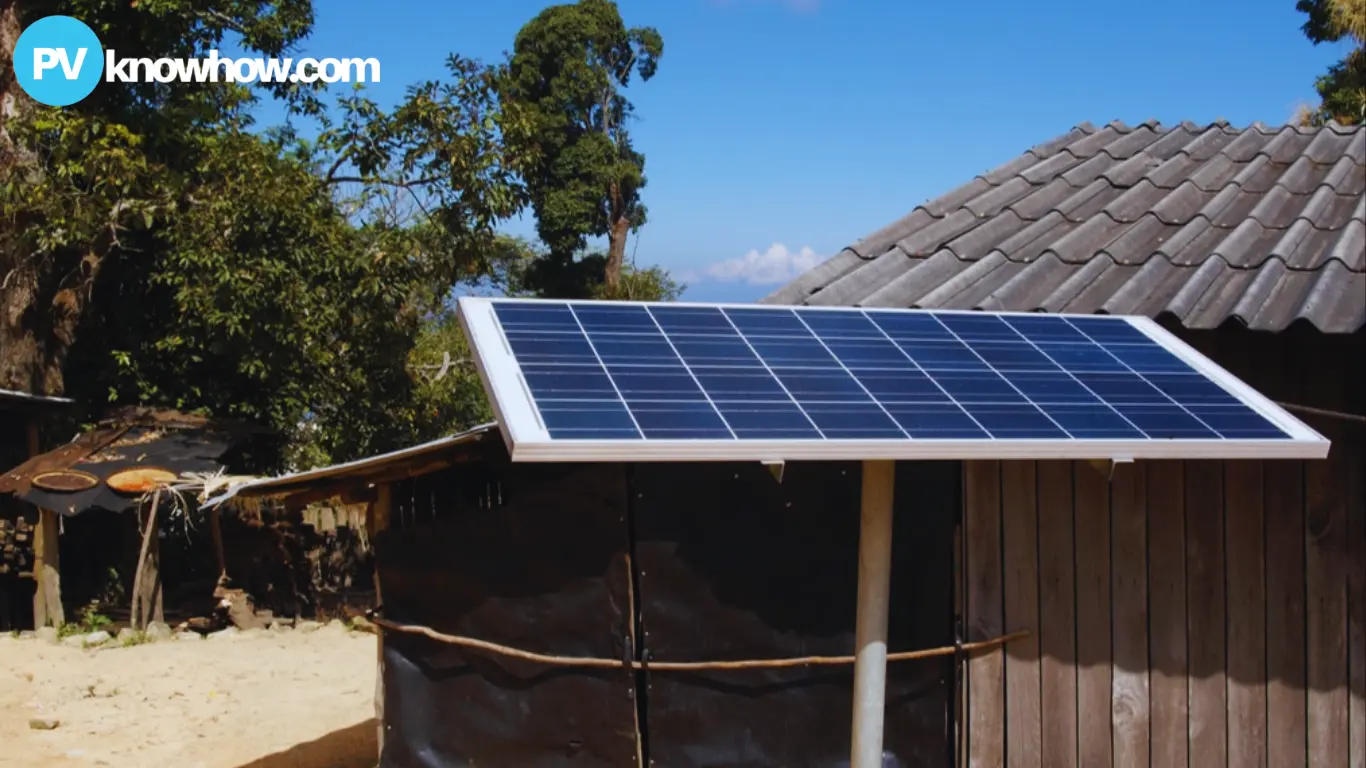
[{"x1": 1147, "y1": 462, "x2": 1190, "y2": 765}]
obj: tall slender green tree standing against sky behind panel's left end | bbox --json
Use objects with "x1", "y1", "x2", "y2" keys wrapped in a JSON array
[{"x1": 503, "y1": 0, "x2": 664, "y2": 297}]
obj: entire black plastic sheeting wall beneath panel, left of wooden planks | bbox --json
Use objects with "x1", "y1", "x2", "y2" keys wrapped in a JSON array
[{"x1": 376, "y1": 462, "x2": 960, "y2": 768}]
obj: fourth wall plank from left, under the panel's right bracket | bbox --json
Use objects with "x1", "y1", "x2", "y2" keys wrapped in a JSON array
[{"x1": 1072, "y1": 462, "x2": 1113, "y2": 768}]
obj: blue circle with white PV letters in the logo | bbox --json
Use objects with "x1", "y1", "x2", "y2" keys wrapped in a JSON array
[{"x1": 14, "y1": 16, "x2": 104, "y2": 107}]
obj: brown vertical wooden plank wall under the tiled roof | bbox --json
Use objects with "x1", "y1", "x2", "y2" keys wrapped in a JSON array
[{"x1": 963, "y1": 442, "x2": 1366, "y2": 768}]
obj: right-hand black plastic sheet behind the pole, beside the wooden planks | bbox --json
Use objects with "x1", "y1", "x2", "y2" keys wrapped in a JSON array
[{"x1": 632, "y1": 462, "x2": 959, "y2": 768}]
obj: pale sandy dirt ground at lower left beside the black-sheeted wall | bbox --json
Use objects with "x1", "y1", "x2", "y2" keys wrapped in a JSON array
[{"x1": 0, "y1": 626, "x2": 377, "y2": 768}]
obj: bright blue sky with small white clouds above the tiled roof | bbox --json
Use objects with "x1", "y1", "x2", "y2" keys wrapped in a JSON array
[{"x1": 254, "y1": 0, "x2": 1343, "y2": 301}]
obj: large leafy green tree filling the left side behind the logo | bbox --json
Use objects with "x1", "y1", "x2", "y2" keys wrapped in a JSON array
[{"x1": 0, "y1": 0, "x2": 525, "y2": 459}]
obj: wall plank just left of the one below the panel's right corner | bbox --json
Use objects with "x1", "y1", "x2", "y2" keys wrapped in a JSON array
[{"x1": 1264, "y1": 453, "x2": 1307, "y2": 768}]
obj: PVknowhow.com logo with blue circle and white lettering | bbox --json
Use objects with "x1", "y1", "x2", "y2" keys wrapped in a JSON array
[{"x1": 14, "y1": 16, "x2": 380, "y2": 107}]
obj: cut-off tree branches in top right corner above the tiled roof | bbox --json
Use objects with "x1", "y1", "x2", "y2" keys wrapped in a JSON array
[{"x1": 1295, "y1": 0, "x2": 1366, "y2": 126}]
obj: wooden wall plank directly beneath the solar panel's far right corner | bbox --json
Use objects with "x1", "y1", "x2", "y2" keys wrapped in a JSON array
[{"x1": 1305, "y1": 429, "x2": 1348, "y2": 767}]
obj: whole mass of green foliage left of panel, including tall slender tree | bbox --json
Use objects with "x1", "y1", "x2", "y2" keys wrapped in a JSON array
[{"x1": 0, "y1": 0, "x2": 680, "y2": 469}]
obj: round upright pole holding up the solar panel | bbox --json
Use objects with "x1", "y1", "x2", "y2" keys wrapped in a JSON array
[{"x1": 850, "y1": 461, "x2": 896, "y2": 768}]
